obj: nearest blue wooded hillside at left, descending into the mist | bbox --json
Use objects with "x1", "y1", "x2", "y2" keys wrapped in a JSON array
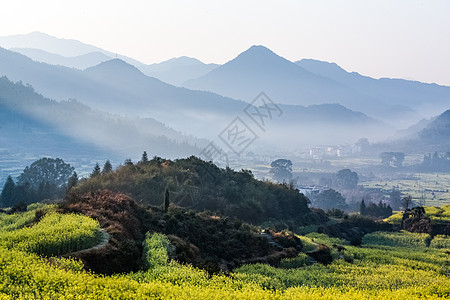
[{"x1": 0, "y1": 77, "x2": 202, "y2": 186}]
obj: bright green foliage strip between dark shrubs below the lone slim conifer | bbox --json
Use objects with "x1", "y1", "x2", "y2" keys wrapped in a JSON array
[{"x1": 143, "y1": 232, "x2": 174, "y2": 269}]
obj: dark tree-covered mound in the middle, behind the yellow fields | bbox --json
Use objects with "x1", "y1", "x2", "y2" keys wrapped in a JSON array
[{"x1": 72, "y1": 156, "x2": 316, "y2": 229}]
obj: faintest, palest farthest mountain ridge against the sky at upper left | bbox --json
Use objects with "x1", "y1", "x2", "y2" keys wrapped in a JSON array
[{"x1": 0, "y1": 31, "x2": 144, "y2": 67}]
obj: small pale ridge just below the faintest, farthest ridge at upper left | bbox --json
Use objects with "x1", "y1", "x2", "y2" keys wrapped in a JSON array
[{"x1": 9, "y1": 48, "x2": 112, "y2": 70}]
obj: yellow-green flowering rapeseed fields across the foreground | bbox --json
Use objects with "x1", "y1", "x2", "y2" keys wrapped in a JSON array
[{"x1": 0, "y1": 204, "x2": 450, "y2": 299}]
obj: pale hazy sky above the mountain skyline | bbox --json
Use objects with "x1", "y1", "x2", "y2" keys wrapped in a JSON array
[{"x1": 0, "y1": 0, "x2": 450, "y2": 85}]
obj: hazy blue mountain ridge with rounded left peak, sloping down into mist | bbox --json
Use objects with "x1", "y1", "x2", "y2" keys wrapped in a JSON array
[{"x1": 0, "y1": 48, "x2": 246, "y2": 137}]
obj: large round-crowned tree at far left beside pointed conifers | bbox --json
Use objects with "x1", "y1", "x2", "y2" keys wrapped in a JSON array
[{"x1": 18, "y1": 158, "x2": 74, "y2": 188}]
